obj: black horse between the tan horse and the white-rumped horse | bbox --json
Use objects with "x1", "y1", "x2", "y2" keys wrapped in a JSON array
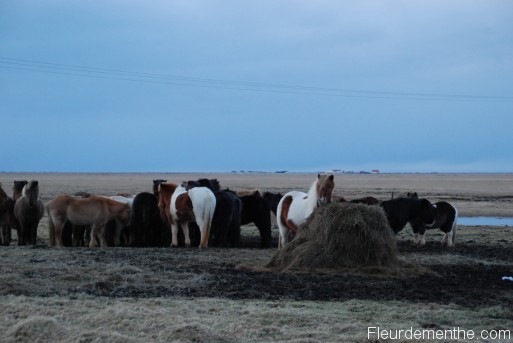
[{"x1": 127, "y1": 192, "x2": 170, "y2": 247}]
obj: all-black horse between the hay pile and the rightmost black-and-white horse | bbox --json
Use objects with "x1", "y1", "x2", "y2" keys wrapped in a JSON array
[{"x1": 379, "y1": 197, "x2": 435, "y2": 233}]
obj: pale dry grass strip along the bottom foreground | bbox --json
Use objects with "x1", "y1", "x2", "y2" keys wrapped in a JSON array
[{"x1": 0, "y1": 296, "x2": 511, "y2": 342}]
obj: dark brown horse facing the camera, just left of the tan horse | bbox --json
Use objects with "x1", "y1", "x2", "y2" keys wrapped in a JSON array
[{"x1": 14, "y1": 180, "x2": 45, "y2": 245}]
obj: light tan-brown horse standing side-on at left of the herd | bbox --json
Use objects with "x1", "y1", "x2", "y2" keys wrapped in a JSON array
[{"x1": 47, "y1": 195, "x2": 130, "y2": 247}]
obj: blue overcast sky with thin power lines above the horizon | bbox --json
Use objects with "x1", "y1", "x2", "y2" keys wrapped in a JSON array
[{"x1": 0, "y1": 0, "x2": 513, "y2": 172}]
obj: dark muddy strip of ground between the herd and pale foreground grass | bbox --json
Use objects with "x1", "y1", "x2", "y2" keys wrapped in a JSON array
[{"x1": 0, "y1": 235, "x2": 513, "y2": 307}]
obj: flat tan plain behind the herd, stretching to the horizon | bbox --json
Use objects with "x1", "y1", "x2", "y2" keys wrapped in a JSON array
[{"x1": 0, "y1": 173, "x2": 513, "y2": 217}]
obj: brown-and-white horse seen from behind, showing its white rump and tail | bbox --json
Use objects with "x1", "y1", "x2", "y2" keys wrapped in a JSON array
[{"x1": 170, "y1": 186, "x2": 216, "y2": 248}]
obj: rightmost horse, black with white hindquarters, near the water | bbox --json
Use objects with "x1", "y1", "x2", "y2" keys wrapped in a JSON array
[{"x1": 410, "y1": 201, "x2": 458, "y2": 247}]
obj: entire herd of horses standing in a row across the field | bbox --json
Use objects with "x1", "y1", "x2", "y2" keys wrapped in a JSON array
[{"x1": 0, "y1": 174, "x2": 458, "y2": 248}]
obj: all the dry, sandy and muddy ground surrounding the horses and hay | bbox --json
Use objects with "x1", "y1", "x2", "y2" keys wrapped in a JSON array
[{"x1": 0, "y1": 173, "x2": 513, "y2": 342}]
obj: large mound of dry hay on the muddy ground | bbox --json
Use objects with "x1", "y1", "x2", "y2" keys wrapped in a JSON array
[{"x1": 266, "y1": 203, "x2": 398, "y2": 271}]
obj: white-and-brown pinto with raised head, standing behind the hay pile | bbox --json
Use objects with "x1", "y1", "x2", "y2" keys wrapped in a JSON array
[{"x1": 277, "y1": 174, "x2": 335, "y2": 248}]
